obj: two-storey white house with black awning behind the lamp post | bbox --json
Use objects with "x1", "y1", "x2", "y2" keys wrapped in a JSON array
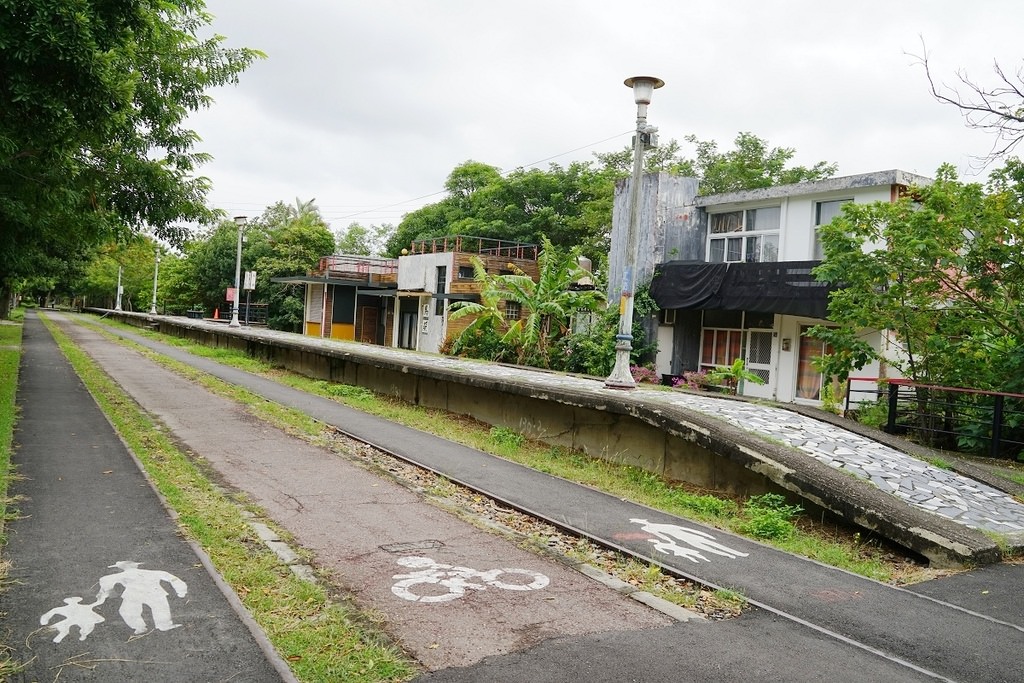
[{"x1": 608, "y1": 170, "x2": 930, "y2": 403}]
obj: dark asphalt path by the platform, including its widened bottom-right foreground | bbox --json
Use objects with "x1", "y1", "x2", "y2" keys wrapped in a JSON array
[{"x1": 28, "y1": 313, "x2": 1024, "y2": 681}]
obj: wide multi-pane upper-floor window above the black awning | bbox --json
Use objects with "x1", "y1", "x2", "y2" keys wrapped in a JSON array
[{"x1": 708, "y1": 206, "x2": 782, "y2": 263}]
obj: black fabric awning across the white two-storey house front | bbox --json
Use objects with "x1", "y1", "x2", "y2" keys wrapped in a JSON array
[{"x1": 650, "y1": 261, "x2": 833, "y2": 319}]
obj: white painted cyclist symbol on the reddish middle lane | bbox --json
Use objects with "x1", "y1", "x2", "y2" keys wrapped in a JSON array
[{"x1": 391, "y1": 555, "x2": 550, "y2": 602}]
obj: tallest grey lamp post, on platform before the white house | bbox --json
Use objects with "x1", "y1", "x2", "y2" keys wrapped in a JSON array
[{"x1": 604, "y1": 76, "x2": 665, "y2": 389}]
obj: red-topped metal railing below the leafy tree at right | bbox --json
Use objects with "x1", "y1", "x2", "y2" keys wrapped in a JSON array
[{"x1": 846, "y1": 377, "x2": 1024, "y2": 458}]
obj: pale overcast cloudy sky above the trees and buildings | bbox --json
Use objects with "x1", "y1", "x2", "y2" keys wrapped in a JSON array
[{"x1": 187, "y1": 0, "x2": 1024, "y2": 231}]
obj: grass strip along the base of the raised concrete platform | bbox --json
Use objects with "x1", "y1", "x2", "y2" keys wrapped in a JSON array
[{"x1": 77, "y1": 322, "x2": 912, "y2": 582}]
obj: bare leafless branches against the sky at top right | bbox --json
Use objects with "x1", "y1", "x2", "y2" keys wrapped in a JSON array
[{"x1": 914, "y1": 50, "x2": 1024, "y2": 166}]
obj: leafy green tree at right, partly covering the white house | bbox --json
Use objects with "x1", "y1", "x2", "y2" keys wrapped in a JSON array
[{"x1": 814, "y1": 161, "x2": 1024, "y2": 390}]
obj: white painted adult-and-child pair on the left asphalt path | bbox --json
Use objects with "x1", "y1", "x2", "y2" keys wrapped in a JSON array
[{"x1": 39, "y1": 560, "x2": 188, "y2": 643}]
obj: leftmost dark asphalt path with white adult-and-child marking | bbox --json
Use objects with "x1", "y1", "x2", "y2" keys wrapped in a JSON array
[{"x1": 0, "y1": 313, "x2": 295, "y2": 682}]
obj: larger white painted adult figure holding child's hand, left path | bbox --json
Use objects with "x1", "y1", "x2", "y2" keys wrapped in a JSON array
[{"x1": 96, "y1": 560, "x2": 188, "y2": 635}]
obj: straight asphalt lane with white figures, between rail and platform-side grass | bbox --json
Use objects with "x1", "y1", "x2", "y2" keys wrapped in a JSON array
[{"x1": 81, "y1": 317, "x2": 1024, "y2": 681}]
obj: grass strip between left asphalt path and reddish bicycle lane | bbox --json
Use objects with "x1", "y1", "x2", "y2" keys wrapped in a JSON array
[{"x1": 39, "y1": 323, "x2": 416, "y2": 683}]
